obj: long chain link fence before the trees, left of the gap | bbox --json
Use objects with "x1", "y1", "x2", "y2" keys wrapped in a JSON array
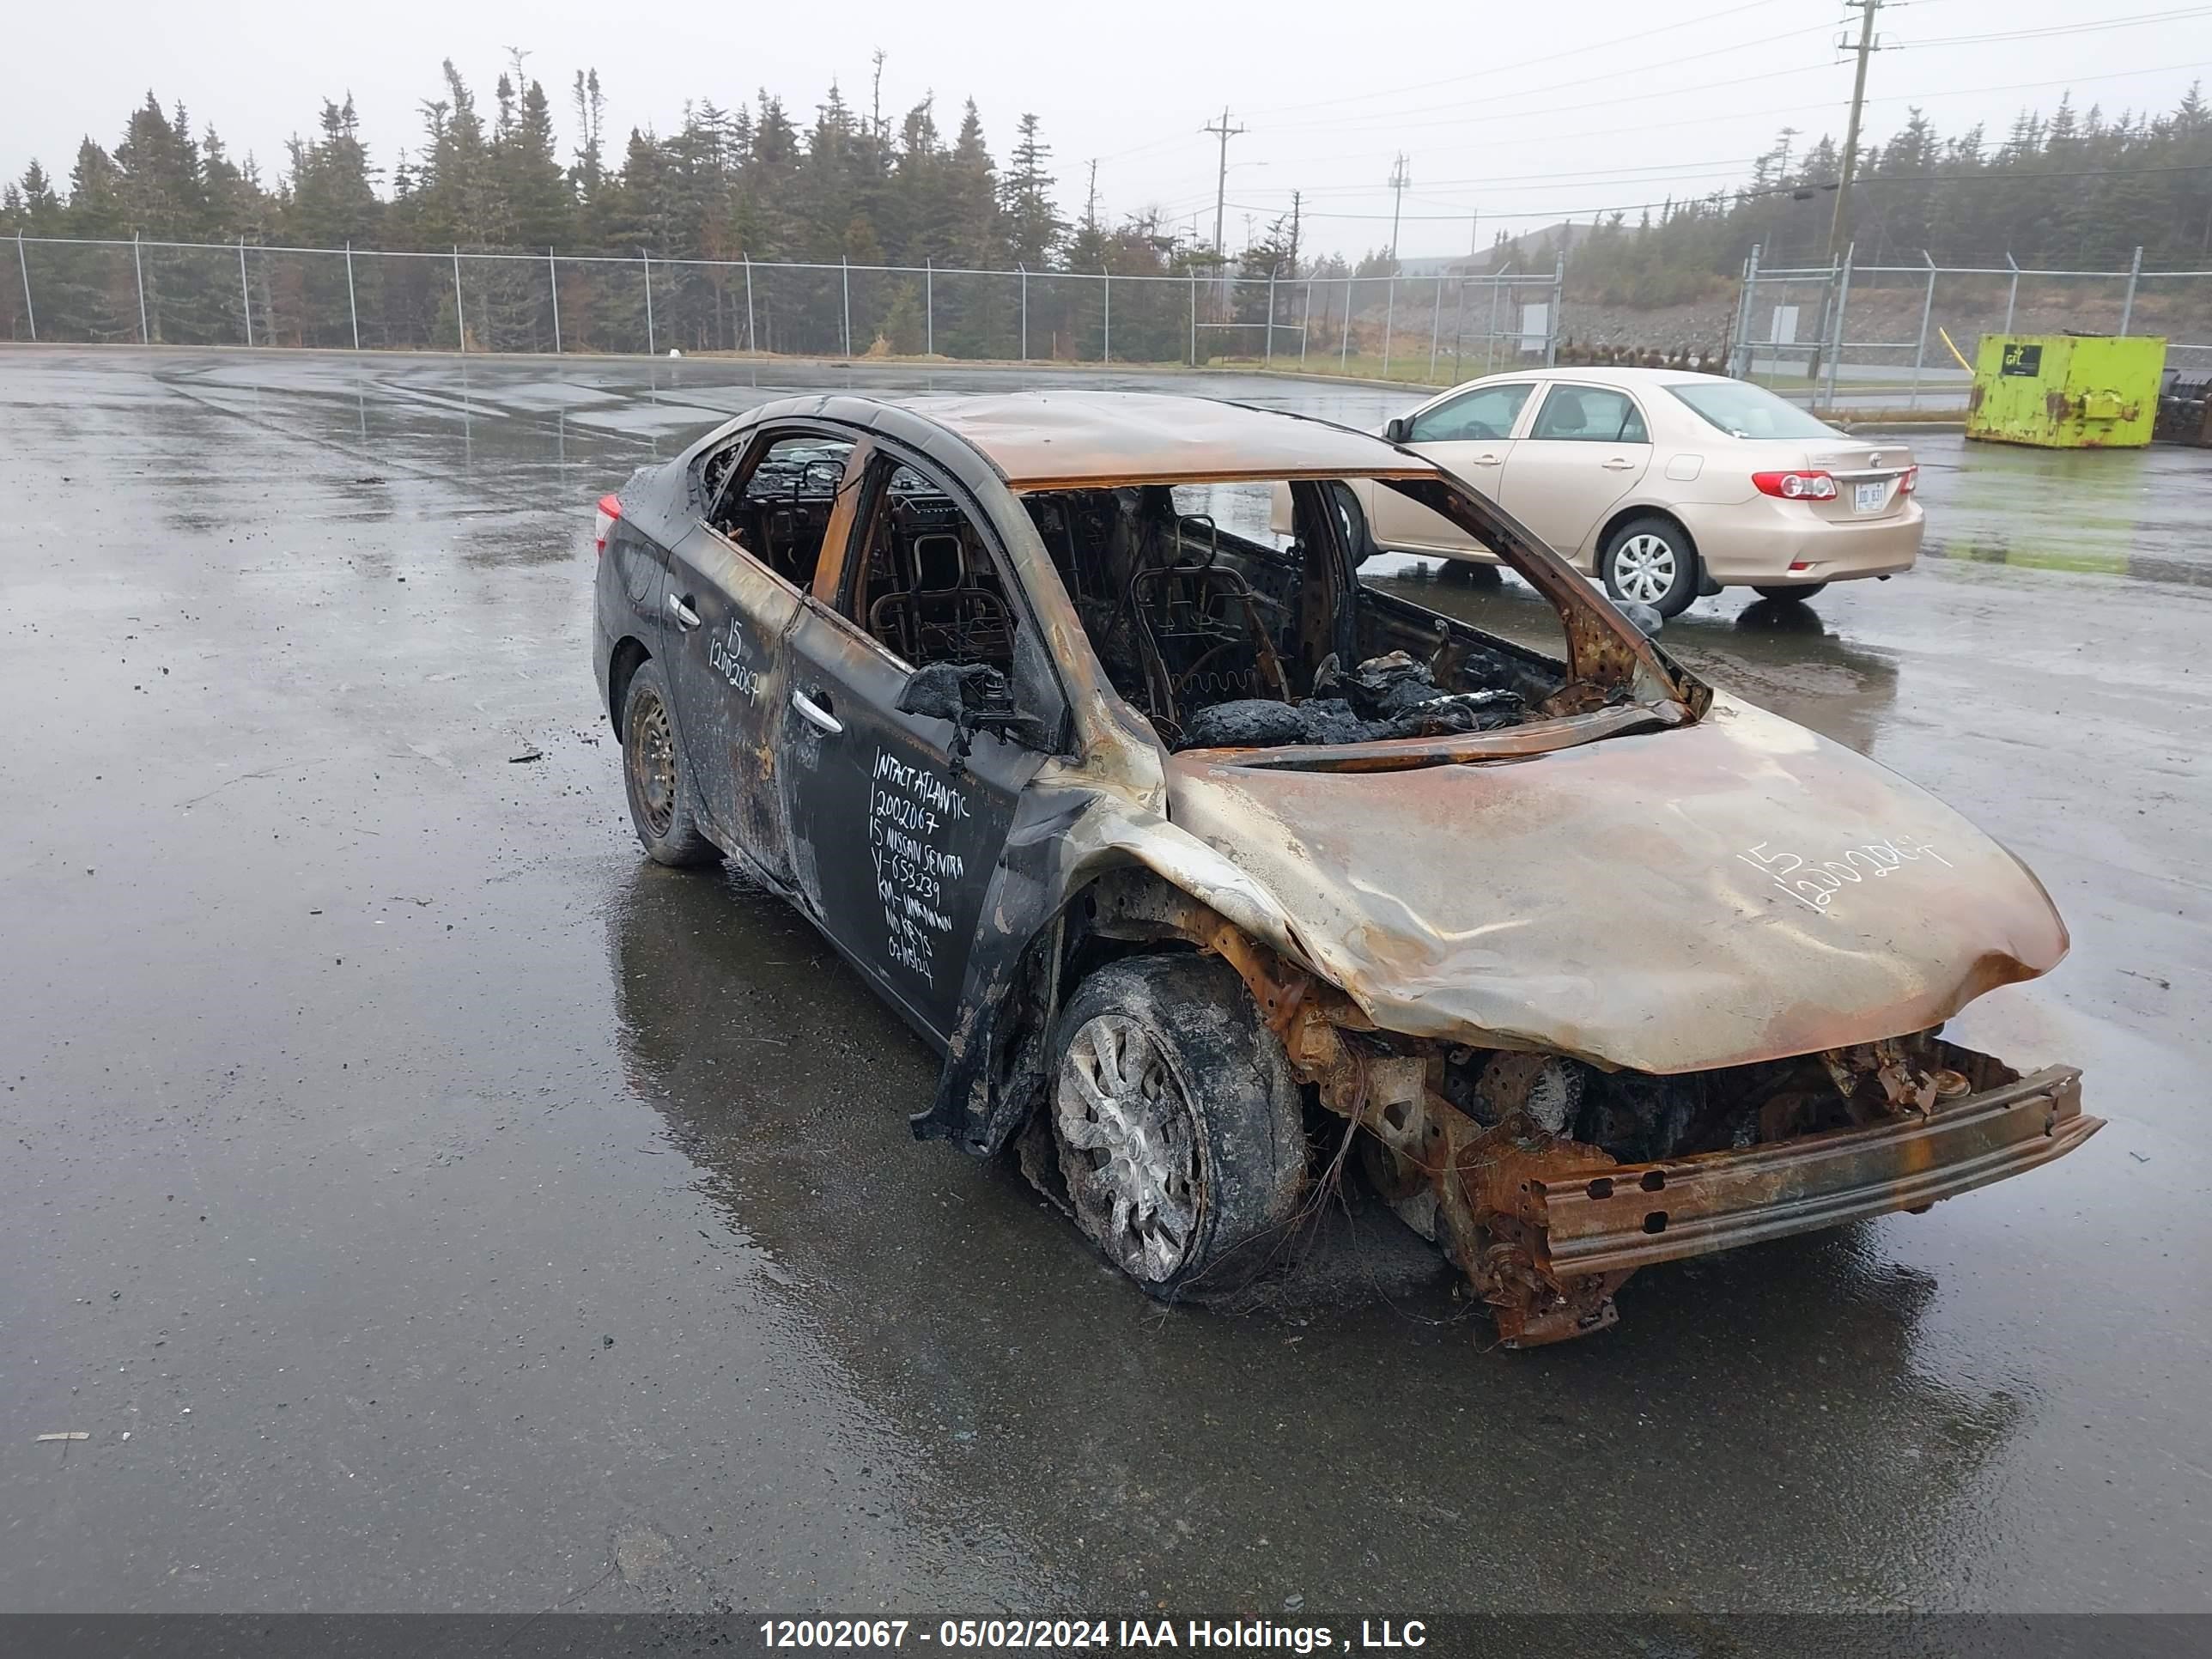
[{"x1": 0, "y1": 237, "x2": 1564, "y2": 383}]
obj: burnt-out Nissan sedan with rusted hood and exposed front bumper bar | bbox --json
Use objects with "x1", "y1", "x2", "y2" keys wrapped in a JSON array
[{"x1": 592, "y1": 392, "x2": 2101, "y2": 1345}]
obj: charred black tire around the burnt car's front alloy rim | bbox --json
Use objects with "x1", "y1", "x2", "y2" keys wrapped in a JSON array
[{"x1": 1044, "y1": 956, "x2": 1307, "y2": 1301}]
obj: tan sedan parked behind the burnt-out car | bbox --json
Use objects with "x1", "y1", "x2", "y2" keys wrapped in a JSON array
[{"x1": 1291, "y1": 369, "x2": 1923, "y2": 617}]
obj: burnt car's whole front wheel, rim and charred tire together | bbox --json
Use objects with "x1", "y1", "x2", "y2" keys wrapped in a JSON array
[{"x1": 1051, "y1": 956, "x2": 1307, "y2": 1297}]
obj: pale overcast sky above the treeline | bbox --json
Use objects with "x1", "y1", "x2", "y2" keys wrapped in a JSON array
[{"x1": 0, "y1": 0, "x2": 2212, "y2": 258}]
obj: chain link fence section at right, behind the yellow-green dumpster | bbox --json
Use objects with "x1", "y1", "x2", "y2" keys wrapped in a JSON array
[{"x1": 1729, "y1": 248, "x2": 2212, "y2": 410}]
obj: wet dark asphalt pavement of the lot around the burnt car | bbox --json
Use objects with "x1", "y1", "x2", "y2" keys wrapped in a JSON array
[{"x1": 0, "y1": 349, "x2": 2212, "y2": 1620}]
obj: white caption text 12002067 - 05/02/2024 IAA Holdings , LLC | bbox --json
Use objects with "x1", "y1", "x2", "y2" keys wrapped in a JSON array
[{"x1": 761, "y1": 1620, "x2": 1429, "y2": 1652}]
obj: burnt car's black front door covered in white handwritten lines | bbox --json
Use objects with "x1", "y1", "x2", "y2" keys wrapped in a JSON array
[{"x1": 781, "y1": 445, "x2": 1064, "y2": 1042}]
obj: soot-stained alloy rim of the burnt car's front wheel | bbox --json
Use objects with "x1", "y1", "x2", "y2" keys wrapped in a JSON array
[{"x1": 1053, "y1": 1013, "x2": 1199, "y2": 1283}]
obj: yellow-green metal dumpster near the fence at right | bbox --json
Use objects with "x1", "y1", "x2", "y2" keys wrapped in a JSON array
[{"x1": 1966, "y1": 334, "x2": 2166, "y2": 449}]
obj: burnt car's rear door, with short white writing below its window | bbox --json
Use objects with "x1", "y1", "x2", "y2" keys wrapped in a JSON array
[{"x1": 665, "y1": 427, "x2": 852, "y2": 883}]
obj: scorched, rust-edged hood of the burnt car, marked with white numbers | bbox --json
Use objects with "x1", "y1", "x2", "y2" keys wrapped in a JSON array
[{"x1": 1168, "y1": 696, "x2": 2066, "y2": 1073}]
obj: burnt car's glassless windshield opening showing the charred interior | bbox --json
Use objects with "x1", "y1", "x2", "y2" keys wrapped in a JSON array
[{"x1": 1024, "y1": 483, "x2": 1610, "y2": 750}]
